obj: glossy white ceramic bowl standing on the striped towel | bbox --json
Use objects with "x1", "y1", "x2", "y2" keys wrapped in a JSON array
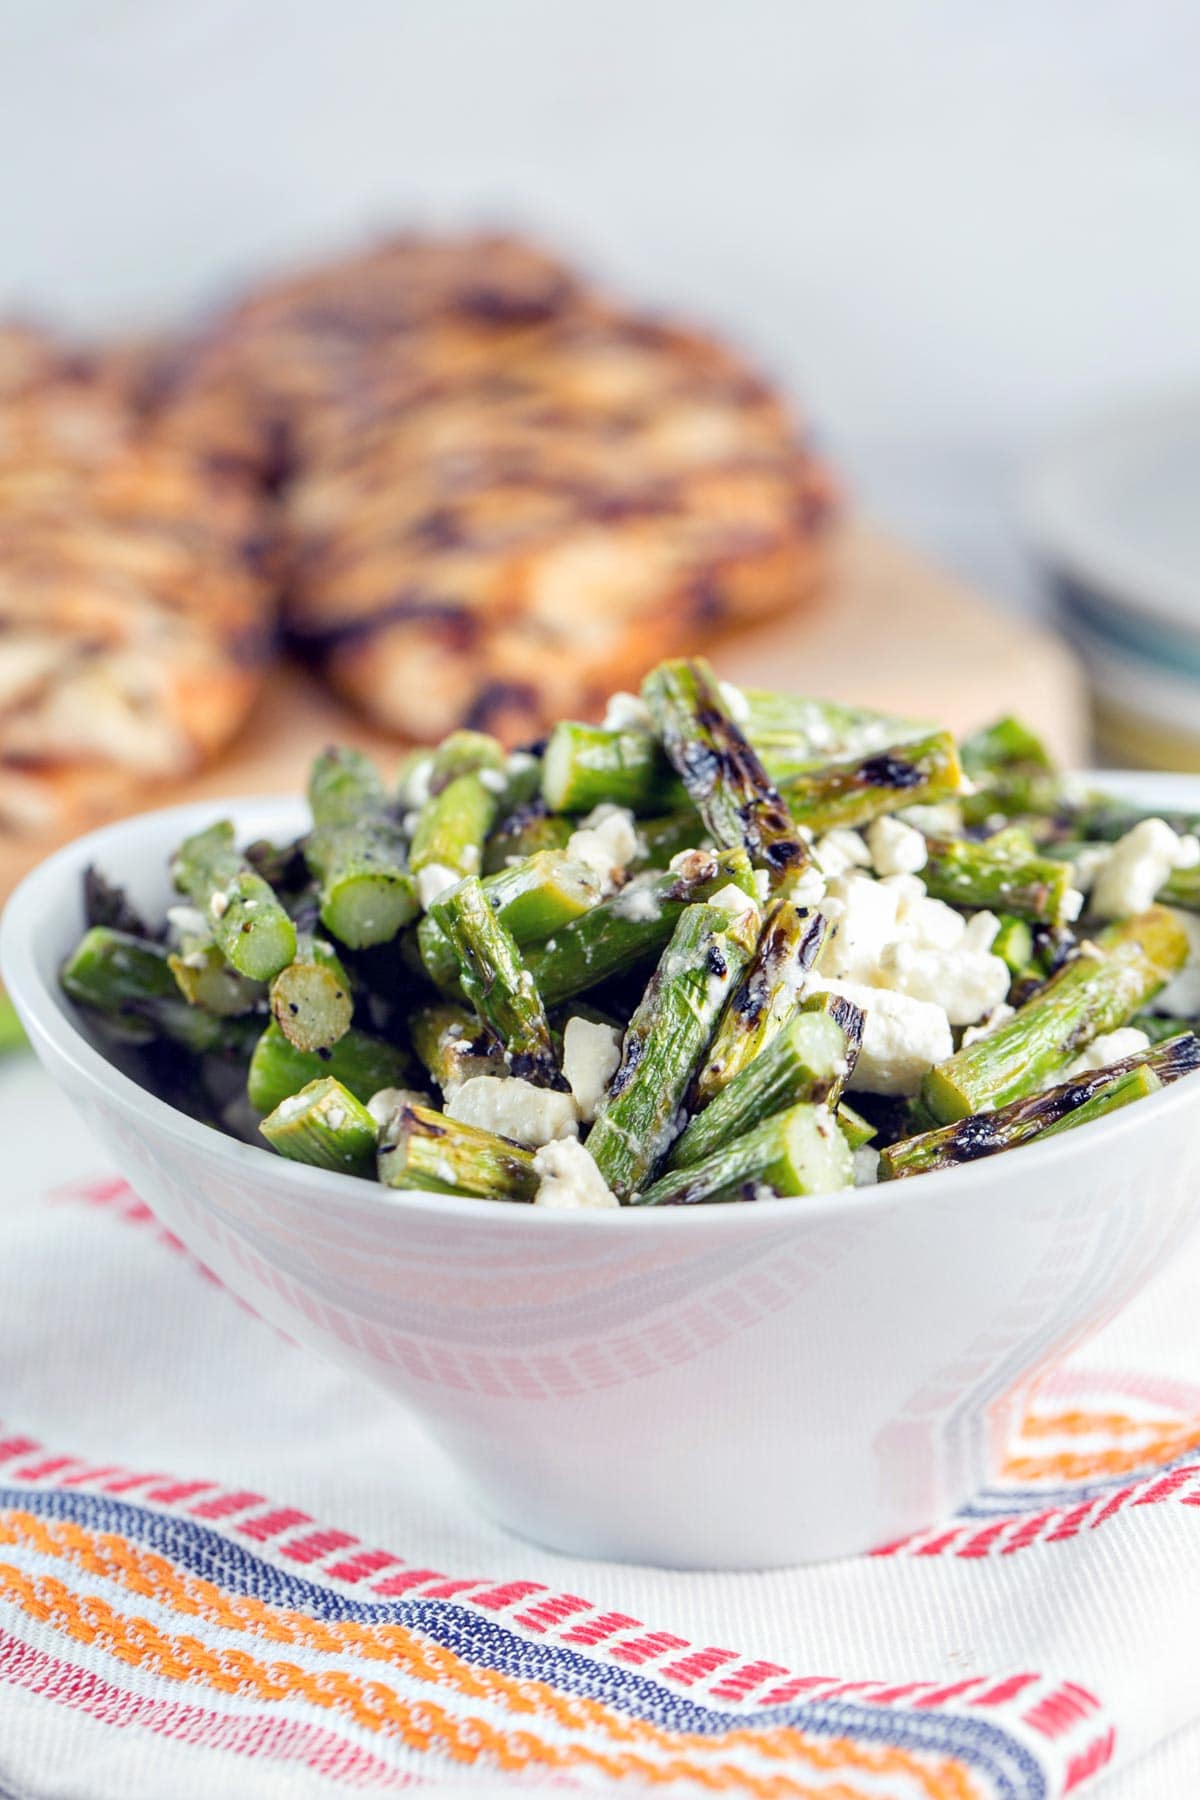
[{"x1": 0, "y1": 776, "x2": 1200, "y2": 1568}]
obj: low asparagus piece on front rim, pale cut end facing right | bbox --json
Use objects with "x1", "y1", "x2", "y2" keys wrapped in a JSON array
[{"x1": 630, "y1": 1105, "x2": 855, "y2": 1206}]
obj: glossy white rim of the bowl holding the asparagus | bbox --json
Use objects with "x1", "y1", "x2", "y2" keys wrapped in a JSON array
[{"x1": 0, "y1": 770, "x2": 1200, "y2": 1231}]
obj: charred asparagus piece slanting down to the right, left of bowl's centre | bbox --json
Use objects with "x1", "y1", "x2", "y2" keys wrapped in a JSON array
[{"x1": 434, "y1": 875, "x2": 567, "y2": 1087}]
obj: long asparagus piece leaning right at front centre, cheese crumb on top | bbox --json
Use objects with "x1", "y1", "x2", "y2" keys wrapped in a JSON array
[{"x1": 588, "y1": 895, "x2": 759, "y2": 1201}]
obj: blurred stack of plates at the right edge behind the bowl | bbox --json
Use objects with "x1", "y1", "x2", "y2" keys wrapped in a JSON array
[{"x1": 1025, "y1": 392, "x2": 1200, "y2": 769}]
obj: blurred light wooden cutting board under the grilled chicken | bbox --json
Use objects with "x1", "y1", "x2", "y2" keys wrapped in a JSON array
[{"x1": 0, "y1": 524, "x2": 1087, "y2": 900}]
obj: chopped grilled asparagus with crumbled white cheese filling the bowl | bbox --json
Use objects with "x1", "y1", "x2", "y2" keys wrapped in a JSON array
[{"x1": 61, "y1": 661, "x2": 1200, "y2": 1208}]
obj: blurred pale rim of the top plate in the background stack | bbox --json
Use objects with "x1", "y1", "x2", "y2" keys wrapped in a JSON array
[{"x1": 1018, "y1": 385, "x2": 1200, "y2": 635}]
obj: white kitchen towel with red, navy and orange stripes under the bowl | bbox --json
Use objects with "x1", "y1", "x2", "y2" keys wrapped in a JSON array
[{"x1": 0, "y1": 1066, "x2": 1200, "y2": 1800}]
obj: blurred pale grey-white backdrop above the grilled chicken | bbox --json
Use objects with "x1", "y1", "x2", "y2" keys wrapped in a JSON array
[{"x1": 0, "y1": 0, "x2": 1200, "y2": 607}]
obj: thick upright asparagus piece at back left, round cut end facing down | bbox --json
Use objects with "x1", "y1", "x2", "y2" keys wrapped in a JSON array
[{"x1": 304, "y1": 749, "x2": 419, "y2": 950}]
